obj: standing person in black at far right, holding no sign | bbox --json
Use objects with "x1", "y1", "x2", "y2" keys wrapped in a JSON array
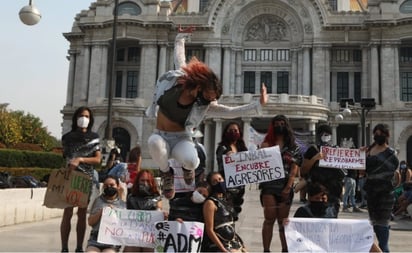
[{"x1": 364, "y1": 124, "x2": 399, "y2": 252}]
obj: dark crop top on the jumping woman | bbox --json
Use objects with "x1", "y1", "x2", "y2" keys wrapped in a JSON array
[{"x1": 157, "y1": 85, "x2": 193, "y2": 127}]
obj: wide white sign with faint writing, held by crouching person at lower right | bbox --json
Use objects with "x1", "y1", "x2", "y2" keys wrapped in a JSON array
[{"x1": 285, "y1": 218, "x2": 374, "y2": 252}]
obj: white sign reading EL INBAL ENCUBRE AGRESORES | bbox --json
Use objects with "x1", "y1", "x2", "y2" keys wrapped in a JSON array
[{"x1": 223, "y1": 146, "x2": 285, "y2": 188}]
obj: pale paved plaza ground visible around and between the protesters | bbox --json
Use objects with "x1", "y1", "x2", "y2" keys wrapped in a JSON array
[{"x1": 0, "y1": 185, "x2": 412, "y2": 252}]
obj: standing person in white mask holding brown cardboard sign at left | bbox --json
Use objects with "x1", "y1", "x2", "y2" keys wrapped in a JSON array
[{"x1": 60, "y1": 107, "x2": 101, "y2": 252}]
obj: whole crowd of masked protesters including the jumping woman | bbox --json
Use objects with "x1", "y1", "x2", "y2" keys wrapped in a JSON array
[{"x1": 60, "y1": 31, "x2": 412, "y2": 252}]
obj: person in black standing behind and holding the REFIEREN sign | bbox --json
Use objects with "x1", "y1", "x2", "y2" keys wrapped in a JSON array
[{"x1": 301, "y1": 125, "x2": 345, "y2": 217}]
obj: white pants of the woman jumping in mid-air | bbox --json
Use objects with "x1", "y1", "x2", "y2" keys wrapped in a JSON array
[{"x1": 147, "y1": 130, "x2": 200, "y2": 172}]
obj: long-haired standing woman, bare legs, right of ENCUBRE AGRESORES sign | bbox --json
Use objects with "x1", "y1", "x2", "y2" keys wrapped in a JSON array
[{"x1": 259, "y1": 115, "x2": 302, "y2": 252}]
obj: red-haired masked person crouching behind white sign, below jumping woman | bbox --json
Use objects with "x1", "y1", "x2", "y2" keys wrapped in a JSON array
[{"x1": 123, "y1": 170, "x2": 162, "y2": 252}]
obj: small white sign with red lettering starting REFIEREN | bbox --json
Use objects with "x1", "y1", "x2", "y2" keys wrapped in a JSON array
[{"x1": 319, "y1": 146, "x2": 366, "y2": 170}]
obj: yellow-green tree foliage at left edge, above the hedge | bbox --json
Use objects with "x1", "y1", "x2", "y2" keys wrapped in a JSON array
[{"x1": 0, "y1": 104, "x2": 60, "y2": 151}]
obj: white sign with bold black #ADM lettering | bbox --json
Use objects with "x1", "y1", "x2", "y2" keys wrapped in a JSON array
[{"x1": 154, "y1": 221, "x2": 204, "y2": 252}]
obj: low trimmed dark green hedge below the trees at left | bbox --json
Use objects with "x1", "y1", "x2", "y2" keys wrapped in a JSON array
[{"x1": 0, "y1": 149, "x2": 65, "y2": 168}]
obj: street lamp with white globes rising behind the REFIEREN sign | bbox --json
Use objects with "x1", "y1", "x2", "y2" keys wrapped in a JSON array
[{"x1": 335, "y1": 98, "x2": 376, "y2": 146}]
